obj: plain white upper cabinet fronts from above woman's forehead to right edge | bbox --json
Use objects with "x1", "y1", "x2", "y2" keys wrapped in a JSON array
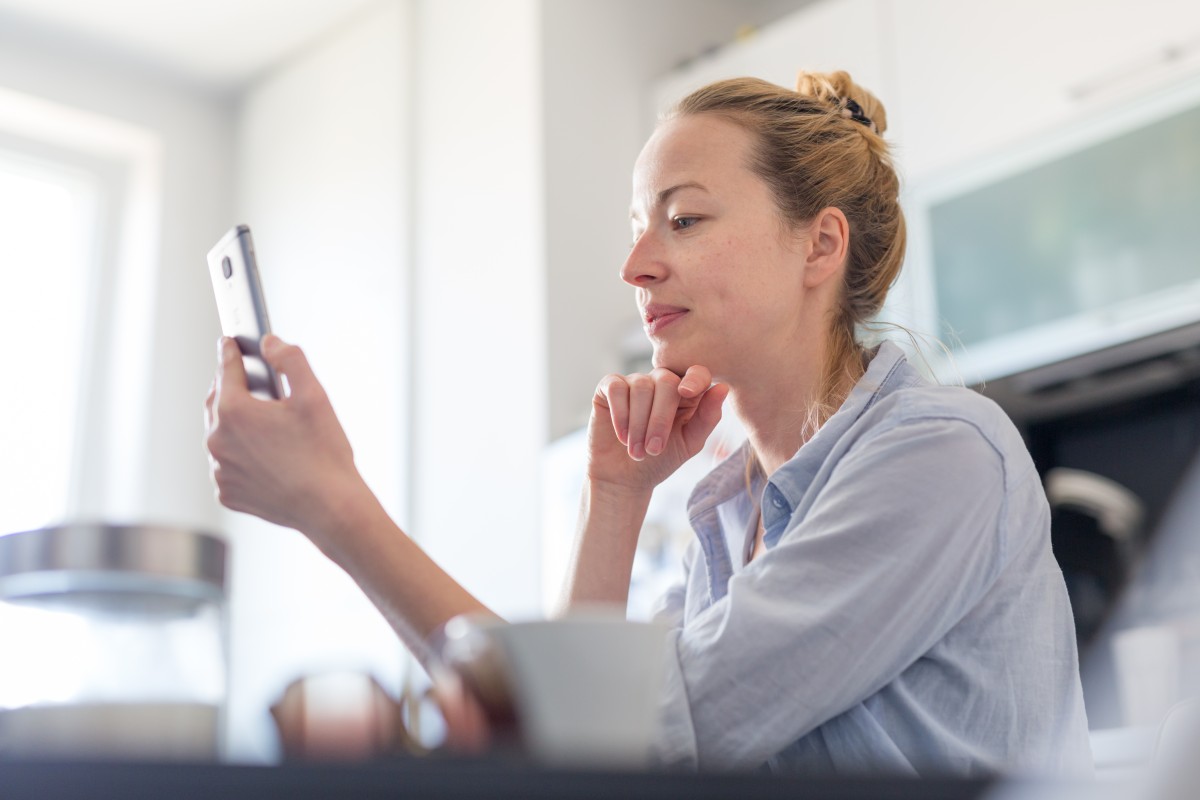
[{"x1": 654, "y1": 0, "x2": 1200, "y2": 182}]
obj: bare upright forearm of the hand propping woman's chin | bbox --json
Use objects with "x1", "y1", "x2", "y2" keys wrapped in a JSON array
[{"x1": 560, "y1": 481, "x2": 650, "y2": 612}]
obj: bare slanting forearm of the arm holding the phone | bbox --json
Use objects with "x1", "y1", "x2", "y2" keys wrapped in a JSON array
[{"x1": 305, "y1": 486, "x2": 492, "y2": 667}]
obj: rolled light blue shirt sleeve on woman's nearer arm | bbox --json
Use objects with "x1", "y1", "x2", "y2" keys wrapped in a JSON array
[{"x1": 658, "y1": 419, "x2": 1006, "y2": 769}]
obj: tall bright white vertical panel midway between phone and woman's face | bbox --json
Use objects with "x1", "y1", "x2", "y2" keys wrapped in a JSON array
[{"x1": 413, "y1": 0, "x2": 546, "y2": 615}]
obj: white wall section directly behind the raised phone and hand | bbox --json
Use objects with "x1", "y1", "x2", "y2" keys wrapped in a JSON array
[{"x1": 226, "y1": 1, "x2": 412, "y2": 760}]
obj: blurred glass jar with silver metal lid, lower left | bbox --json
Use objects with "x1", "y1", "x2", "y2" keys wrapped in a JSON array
[{"x1": 0, "y1": 524, "x2": 228, "y2": 760}]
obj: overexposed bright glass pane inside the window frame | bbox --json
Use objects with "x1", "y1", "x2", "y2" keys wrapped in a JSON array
[{"x1": 0, "y1": 151, "x2": 97, "y2": 534}]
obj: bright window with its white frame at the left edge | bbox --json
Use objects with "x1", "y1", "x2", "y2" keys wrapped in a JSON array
[{"x1": 0, "y1": 88, "x2": 162, "y2": 535}]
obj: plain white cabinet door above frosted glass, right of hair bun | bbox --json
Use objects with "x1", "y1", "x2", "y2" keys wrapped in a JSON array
[{"x1": 884, "y1": 0, "x2": 1200, "y2": 182}]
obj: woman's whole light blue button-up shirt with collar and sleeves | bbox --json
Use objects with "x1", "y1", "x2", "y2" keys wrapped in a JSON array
[{"x1": 658, "y1": 343, "x2": 1092, "y2": 776}]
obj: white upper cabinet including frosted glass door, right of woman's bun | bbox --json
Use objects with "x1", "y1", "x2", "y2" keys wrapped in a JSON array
[{"x1": 890, "y1": 0, "x2": 1200, "y2": 381}]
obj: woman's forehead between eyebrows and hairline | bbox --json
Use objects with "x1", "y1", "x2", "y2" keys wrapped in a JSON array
[{"x1": 634, "y1": 114, "x2": 752, "y2": 210}]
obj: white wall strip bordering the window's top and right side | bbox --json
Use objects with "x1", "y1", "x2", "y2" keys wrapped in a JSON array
[{"x1": 0, "y1": 15, "x2": 233, "y2": 529}]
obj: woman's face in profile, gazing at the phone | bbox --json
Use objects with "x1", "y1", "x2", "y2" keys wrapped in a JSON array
[{"x1": 620, "y1": 115, "x2": 805, "y2": 380}]
